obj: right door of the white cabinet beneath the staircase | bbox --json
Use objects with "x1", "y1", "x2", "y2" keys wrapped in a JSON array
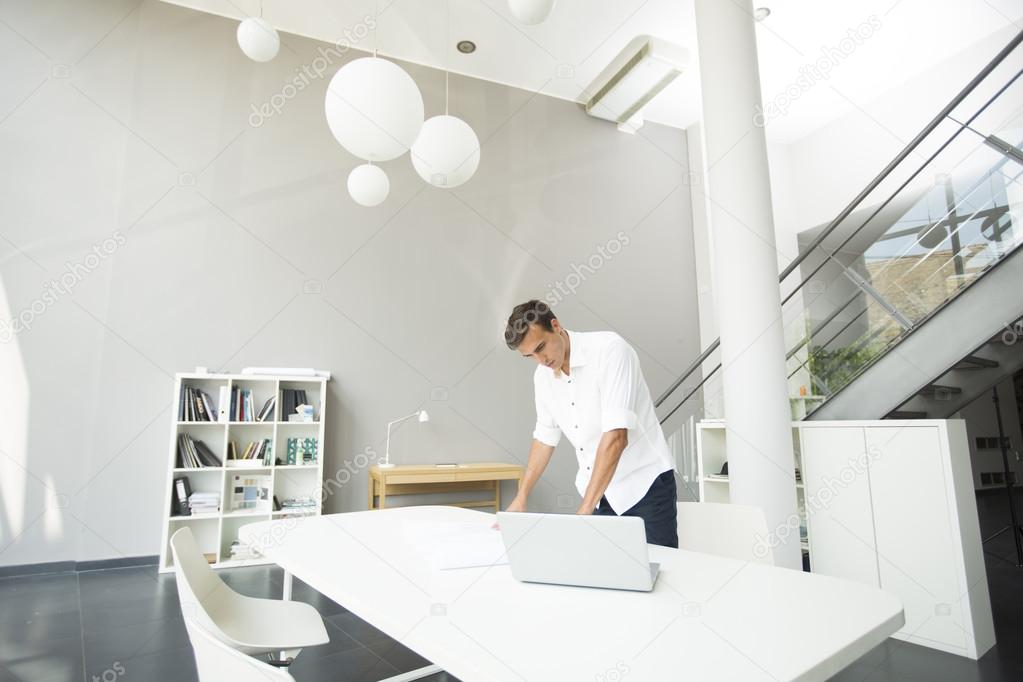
[{"x1": 866, "y1": 426, "x2": 970, "y2": 647}]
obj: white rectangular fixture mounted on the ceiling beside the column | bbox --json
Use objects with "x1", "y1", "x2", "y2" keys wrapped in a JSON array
[{"x1": 586, "y1": 36, "x2": 690, "y2": 133}]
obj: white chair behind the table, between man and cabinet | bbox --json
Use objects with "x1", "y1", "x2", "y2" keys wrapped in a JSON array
[{"x1": 678, "y1": 502, "x2": 773, "y2": 565}]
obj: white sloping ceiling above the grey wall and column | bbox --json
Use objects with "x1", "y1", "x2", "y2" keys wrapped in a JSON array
[{"x1": 159, "y1": 0, "x2": 1023, "y2": 142}]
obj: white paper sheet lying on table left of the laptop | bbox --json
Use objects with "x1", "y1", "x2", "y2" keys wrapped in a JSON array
[{"x1": 404, "y1": 519, "x2": 508, "y2": 571}]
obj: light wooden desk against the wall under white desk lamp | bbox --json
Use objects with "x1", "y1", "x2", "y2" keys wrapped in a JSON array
[{"x1": 369, "y1": 462, "x2": 525, "y2": 512}]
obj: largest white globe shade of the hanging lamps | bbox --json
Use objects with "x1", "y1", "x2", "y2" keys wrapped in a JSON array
[{"x1": 324, "y1": 57, "x2": 424, "y2": 161}]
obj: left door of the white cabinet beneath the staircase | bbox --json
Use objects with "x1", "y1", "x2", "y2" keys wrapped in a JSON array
[{"x1": 801, "y1": 426, "x2": 879, "y2": 587}]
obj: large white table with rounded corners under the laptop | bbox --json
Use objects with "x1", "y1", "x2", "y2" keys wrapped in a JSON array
[{"x1": 239, "y1": 506, "x2": 904, "y2": 682}]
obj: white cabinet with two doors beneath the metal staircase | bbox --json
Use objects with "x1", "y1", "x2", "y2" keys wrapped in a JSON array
[{"x1": 799, "y1": 419, "x2": 994, "y2": 658}]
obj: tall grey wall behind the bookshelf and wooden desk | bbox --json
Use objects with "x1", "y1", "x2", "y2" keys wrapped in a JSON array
[{"x1": 0, "y1": 0, "x2": 699, "y2": 564}]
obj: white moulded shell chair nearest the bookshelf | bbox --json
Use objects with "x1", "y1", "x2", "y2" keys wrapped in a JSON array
[{"x1": 171, "y1": 528, "x2": 330, "y2": 662}]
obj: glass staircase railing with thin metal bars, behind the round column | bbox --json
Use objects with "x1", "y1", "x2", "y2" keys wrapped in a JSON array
[{"x1": 656, "y1": 32, "x2": 1023, "y2": 481}]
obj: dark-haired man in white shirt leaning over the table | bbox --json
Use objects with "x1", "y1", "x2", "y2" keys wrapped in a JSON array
[{"x1": 504, "y1": 300, "x2": 678, "y2": 547}]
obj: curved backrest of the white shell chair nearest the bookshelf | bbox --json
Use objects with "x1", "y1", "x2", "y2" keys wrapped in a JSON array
[{"x1": 171, "y1": 528, "x2": 233, "y2": 641}]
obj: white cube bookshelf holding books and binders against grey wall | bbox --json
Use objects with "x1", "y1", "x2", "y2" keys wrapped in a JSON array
[{"x1": 160, "y1": 373, "x2": 327, "y2": 572}]
